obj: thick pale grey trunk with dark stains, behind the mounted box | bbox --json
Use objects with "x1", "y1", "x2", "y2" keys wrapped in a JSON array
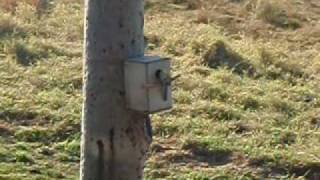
[{"x1": 80, "y1": 0, "x2": 151, "y2": 180}]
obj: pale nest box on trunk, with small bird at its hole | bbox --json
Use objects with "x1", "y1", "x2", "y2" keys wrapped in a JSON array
[{"x1": 124, "y1": 56, "x2": 175, "y2": 113}]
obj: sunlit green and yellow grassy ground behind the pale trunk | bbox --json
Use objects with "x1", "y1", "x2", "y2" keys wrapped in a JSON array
[{"x1": 0, "y1": 0, "x2": 320, "y2": 180}]
